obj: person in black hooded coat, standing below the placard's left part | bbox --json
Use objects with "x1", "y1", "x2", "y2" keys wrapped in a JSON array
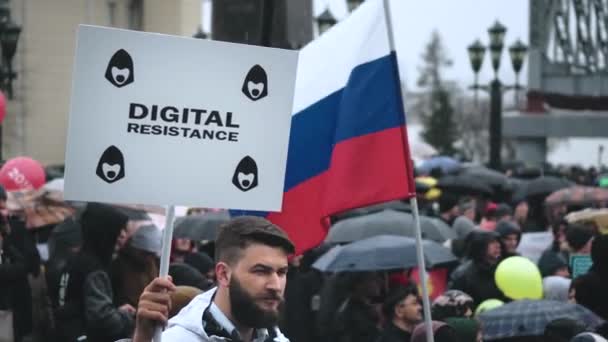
[{"x1": 55, "y1": 203, "x2": 135, "y2": 342}]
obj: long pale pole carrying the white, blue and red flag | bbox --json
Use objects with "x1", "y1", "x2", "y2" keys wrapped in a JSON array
[{"x1": 383, "y1": 0, "x2": 435, "y2": 342}]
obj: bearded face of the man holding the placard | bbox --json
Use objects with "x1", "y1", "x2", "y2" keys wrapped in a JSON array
[{"x1": 229, "y1": 244, "x2": 288, "y2": 328}]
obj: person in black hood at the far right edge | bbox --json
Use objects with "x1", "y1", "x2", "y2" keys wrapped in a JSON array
[{"x1": 574, "y1": 235, "x2": 608, "y2": 320}]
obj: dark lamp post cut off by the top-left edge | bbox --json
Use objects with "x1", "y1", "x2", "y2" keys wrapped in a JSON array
[{"x1": 0, "y1": 0, "x2": 21, "y2": 161}]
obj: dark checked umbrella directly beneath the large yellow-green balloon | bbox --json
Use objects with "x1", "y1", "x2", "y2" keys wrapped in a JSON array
[{"x1": 479, "y1": 300, "x2": 603, "y2": 341}]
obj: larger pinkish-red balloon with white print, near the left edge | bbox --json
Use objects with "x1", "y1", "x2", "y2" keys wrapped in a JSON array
[{"x1": 0, "y1": 157, "x2": 46, "y2": 191}]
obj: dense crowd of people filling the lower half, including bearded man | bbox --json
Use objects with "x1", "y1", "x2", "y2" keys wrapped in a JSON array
[{"x1": 0, "y1": 161, "x2": 608, "y2": 342}]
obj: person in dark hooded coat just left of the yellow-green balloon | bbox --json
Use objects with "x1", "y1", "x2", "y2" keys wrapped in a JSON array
[{"x1": 450, "y1": 231, "x2": 505, "y2": 306}]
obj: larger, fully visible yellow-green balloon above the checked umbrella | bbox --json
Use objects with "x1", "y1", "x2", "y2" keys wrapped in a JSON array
[{"x1": 494, "y1": 256, "x2": 543, "y2": 299}]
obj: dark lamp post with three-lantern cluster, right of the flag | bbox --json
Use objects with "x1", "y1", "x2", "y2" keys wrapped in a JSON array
[{"x1": 468, "y1": 21, "x2": 527, "y2": 170}]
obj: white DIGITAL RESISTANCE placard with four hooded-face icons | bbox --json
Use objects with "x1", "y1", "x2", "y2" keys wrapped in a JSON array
[{"x1": 65, "y1": 25, "x2": 298, "y2": 211}]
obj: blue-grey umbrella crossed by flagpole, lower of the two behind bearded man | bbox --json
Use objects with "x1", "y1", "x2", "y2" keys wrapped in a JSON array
[{"x1": 313, "y1": 235, "x2": 458, "y2": 272}]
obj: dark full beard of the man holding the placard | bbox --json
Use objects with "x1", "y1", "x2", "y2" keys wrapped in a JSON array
[{"x1": 229, "y1": 275, "x2": 283, "y2": 329}]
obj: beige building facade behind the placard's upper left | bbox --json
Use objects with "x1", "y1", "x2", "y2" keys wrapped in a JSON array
[{"x1": 7, "y1": 0, "x2": 201, "y2": 164}]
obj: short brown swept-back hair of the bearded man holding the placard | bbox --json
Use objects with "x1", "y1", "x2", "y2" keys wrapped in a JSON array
[{"x1": 215, "y1": 216, "x2": 295, "y2": 264}]
